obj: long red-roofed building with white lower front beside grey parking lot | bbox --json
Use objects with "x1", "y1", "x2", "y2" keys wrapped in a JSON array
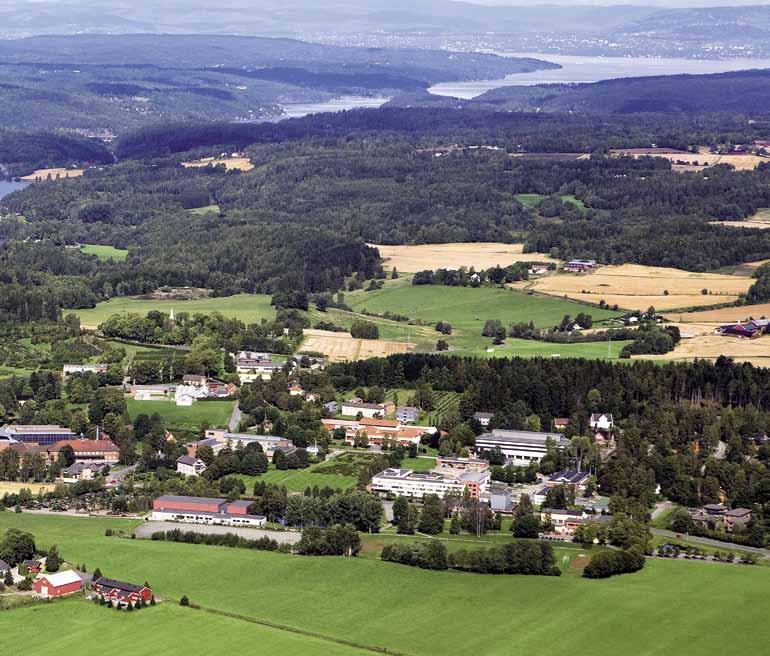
[{"x1": 150, "y1": 495, "x2": 267, "y2": 527}]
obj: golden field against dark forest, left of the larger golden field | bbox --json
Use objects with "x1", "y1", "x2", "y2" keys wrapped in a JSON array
[{"x1": 369, "y1": 242, "x2": 555, "y2": 273}]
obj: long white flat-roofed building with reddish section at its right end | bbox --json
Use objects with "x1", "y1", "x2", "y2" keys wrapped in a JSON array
[{"x1": 369, "y1": 468, "x2": 490, "y2": 499}]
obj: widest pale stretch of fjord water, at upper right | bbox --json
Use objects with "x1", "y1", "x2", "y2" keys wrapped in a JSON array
[{"x1": 428, "y1": 52, "x2": 770, "y2": 100}]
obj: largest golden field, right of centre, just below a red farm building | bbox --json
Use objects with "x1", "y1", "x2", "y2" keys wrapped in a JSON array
[{"x1": 511, "y1": 264, "x2": 752, "y2": 310}]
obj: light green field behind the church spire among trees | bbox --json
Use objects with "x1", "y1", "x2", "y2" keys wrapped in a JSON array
[{"x1": 74, "y1": 294, "x2": 275, "y2": 326}]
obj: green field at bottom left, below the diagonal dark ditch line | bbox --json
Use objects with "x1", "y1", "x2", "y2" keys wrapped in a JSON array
[{"x1": 0, "y1": 599, "x2": 368, "y2": 656}]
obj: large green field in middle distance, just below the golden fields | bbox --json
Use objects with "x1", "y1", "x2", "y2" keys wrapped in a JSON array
[{"x1": 345, "y1": 281, "x2": 624, "y2": 358}]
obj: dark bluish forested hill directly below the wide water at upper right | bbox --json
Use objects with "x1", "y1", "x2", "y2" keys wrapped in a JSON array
[{"x1": 466, "y1": 69, "x2": 770, "y2": 114}]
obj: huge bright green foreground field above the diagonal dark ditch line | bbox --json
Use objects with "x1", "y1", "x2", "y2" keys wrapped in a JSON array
[{"x1": 0, "y1": 513, "x2": 770, "y2": 656}]
